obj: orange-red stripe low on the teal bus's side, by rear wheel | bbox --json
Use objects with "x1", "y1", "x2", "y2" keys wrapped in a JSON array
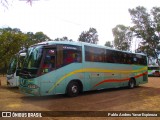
[{"x1": 93, "y1": 72, "x2": 147, "y2": 88}]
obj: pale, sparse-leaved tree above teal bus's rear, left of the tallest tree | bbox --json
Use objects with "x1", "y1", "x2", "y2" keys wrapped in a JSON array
[{"x1": 112, "y1": 25, "x2": 132, "y2": 51}]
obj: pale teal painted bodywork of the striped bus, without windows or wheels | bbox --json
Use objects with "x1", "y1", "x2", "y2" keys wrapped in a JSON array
[{"x1": 20, "y1": 43, "x2": 148, "y2": 96}]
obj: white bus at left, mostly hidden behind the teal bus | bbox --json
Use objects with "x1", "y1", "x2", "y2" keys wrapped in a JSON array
[{"x1": 7, "y1": 52, "x2": 26, "y2": 87}]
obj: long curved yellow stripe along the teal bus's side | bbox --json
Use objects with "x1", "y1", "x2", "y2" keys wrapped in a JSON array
[{"x1": 48, "y1": 67, "x2": 147, "y2": 93}]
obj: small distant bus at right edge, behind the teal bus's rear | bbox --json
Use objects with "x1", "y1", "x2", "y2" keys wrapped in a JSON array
[{"x1": 148, "y1": 66, "x2": 160, "y2": 77}]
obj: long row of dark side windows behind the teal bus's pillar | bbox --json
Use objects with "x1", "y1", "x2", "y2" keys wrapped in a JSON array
[{"x1": 85, "y1": 46, "x2": 147, "y2": 65}]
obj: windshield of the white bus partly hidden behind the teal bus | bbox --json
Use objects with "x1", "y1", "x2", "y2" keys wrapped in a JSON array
[{"x1": 7, "y1": 55, "x2": 17, "y2": 75}]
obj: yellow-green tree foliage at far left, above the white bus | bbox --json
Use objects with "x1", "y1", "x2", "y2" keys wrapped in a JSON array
[{"x1": 0, "y1": 28, "x2": 50, "y2": 71}]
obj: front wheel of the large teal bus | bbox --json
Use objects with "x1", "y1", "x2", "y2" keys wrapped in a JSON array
[{"x1": 66, "y1": 81, "x2": 80, "y2": 97}]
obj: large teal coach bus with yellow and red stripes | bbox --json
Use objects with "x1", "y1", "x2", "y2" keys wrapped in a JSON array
[{"x1": 19, "y1": 41, "x2": 148, "y2": 97}]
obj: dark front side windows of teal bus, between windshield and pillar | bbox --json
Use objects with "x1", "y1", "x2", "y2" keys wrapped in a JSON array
[{"x1": 41, "y1": 45, "x2": 82, "y2": 74}]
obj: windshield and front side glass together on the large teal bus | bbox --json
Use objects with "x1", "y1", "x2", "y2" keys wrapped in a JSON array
[{"x1": 20, "y1": 44, "x2": 82, "y2": 78}]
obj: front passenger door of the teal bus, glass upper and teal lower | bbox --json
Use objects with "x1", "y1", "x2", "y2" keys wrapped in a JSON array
[{"x1": 39, "y1": 47, "x2": 56, "y2": 95}]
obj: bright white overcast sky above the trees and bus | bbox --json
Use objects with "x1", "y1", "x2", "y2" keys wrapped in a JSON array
[{"x1": 0, "y1": 0, "x2": 160, "y2": 45}]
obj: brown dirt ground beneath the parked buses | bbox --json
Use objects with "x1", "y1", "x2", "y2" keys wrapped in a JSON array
[{"x1": 0, "y1": 77, "x2": 160, "y2": 120}]
